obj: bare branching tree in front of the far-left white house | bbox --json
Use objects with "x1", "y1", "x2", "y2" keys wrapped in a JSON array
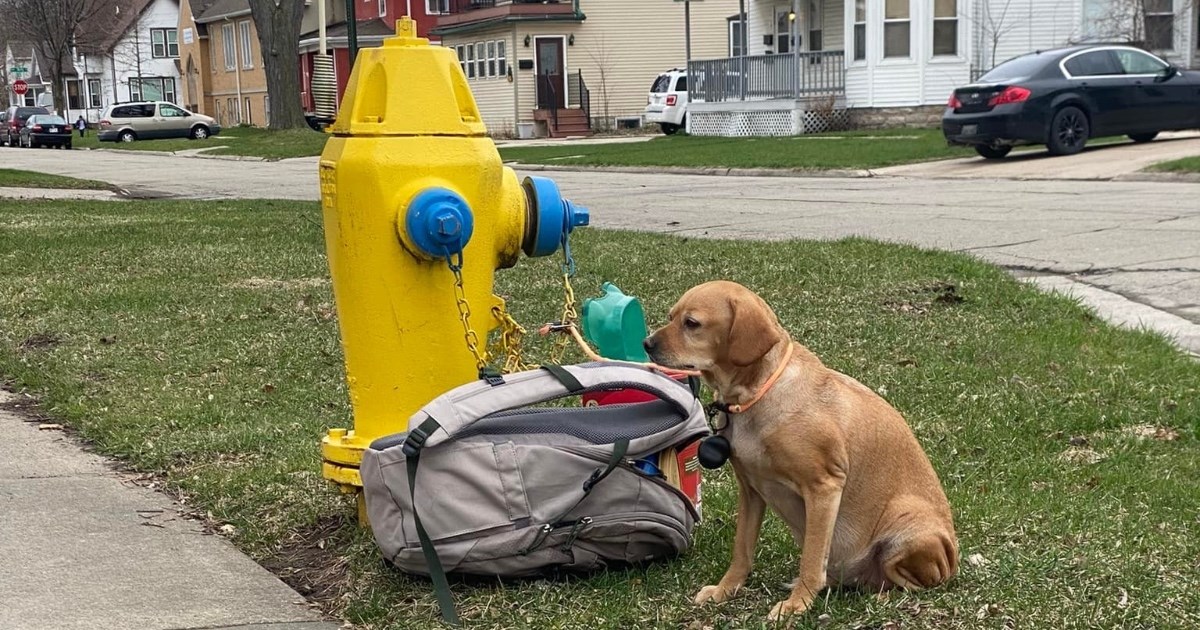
[{"x1": 0, "y1": 0, "x2": 128, "y2": 110}]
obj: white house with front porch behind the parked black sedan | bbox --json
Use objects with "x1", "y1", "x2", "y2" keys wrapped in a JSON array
[{"x1": 688, "y1": 0, "x2": 1200, "y2": 136}]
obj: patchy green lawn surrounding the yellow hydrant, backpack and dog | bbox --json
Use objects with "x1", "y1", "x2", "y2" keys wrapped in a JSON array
[{"x1": 0, "y1": 199, "x2": 1200, "y2": 630}]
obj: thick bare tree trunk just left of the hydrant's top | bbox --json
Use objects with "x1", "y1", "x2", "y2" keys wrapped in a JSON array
[{"x1": 250, "y1": 0, "x2": 304, "y2": 130}]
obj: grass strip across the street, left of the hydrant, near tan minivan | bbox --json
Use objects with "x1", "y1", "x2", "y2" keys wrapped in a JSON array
[{"x1": 73, "y1": 127, "x2": 328, "y2": 160}]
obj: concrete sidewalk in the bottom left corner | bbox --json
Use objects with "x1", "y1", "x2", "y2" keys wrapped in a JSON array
[{"x1": 0, "y1": 390, "x2": 340, "y2": 630}]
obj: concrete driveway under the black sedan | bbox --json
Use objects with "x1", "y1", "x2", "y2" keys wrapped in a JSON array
[{"x1": 874, "y1": 132, "x2": 1200, "y2": 180}]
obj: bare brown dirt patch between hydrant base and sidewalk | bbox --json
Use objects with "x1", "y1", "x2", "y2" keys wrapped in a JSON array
[{"x1": 259, "y1": 516, "x2": 350, "y2": 611}]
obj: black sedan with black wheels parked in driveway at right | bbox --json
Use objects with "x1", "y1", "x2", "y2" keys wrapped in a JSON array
[{"x1": 942, "y1": 46, "x2": 1200, "y2": 160}]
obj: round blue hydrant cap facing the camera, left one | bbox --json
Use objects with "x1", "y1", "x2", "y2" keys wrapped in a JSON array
[{"x1": 404, "y1": 187, "x2": 475, "y2": 258}]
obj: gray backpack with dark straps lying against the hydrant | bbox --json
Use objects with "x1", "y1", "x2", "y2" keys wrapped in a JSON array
[{"x1": 360, "y1": 362, "x2": 709, "y2": 623}]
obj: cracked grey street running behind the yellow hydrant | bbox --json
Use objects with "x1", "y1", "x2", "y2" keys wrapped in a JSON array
[{"x1": 0, "y1": 147, "x2": 1200, "y2": 353}]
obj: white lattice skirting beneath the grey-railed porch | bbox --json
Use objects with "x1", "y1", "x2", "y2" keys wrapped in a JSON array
[{"x1": 688, "y1": 101, "x2": 850, "y2": 138}]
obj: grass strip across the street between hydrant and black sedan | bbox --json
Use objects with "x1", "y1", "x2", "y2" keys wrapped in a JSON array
[{"x1": 500, "y1": 128, "x2": 976, "y2": 169}]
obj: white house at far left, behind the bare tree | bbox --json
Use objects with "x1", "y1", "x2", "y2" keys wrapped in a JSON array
[{"x1": 5, "y1": 0, "x2": 180, "y2": 122}]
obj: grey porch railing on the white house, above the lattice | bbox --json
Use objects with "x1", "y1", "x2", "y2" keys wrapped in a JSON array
[{"x1": 688, "y1": 50, "x2": 846, "y2": 103}]
